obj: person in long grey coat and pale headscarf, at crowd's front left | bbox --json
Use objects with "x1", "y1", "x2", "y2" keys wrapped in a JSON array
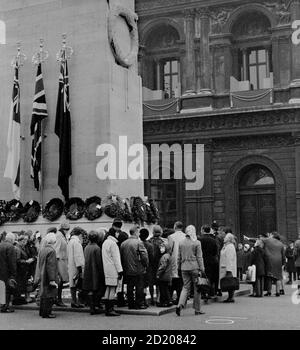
[{"x1": 38, "y1": 232, "x2": 58, "y2": 318}]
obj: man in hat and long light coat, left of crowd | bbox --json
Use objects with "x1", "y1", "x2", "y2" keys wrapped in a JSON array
[{"x1": 54, "y1": 222, "x2": 70, "y2": 307}]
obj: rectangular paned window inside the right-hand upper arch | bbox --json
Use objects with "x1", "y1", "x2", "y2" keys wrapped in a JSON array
[{"x1": 239, "y1": 47, "x2": 272, "y2": 90}]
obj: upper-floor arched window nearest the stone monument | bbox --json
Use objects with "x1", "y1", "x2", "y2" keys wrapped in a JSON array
[{"x1": 141, "y1": 24, "x2": 181, "y2": 99}]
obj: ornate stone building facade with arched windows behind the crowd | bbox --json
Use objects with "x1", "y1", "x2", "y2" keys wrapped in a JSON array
[{"x1": 136, "y1": 0, "x2": 300, "y2": 239}]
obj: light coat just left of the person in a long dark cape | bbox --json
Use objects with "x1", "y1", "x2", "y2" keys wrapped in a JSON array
[{"x1": 68, "y1": 236, "x2": 84, "y2": 287}]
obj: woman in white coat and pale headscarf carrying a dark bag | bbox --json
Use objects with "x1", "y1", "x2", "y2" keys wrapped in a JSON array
[{"x1": 220, "y1": 233, "x2": 237, "y2": 303}]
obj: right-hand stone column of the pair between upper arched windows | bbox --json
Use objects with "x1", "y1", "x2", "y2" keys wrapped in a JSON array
[{"x1": 197, "y1": 8, "x2": 211, "y2": 94}]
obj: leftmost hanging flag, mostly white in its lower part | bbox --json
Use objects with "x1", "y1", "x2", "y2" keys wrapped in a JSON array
[{"x1": 4, "y1": 63, "x2": 21, "y2": 199}]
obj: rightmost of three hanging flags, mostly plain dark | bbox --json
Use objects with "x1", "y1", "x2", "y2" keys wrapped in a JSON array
[{"x1": 55, "y1": 59, "x2": 72, "y2": 200}]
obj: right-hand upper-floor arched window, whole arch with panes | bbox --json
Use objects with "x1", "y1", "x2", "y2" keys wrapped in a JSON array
[{"x1": 232, "y1": 11, "x2": 273, "y2": 90}]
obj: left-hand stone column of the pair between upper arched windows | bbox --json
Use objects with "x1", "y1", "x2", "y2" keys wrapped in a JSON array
[{"x1": 182, "y1": 10, "x2": 196, "y2": 94}]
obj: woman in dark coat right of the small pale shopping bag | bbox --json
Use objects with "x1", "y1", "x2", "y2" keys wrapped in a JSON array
[{"x1": 250, "y1": 239, "x2": 268, "y2": 298}]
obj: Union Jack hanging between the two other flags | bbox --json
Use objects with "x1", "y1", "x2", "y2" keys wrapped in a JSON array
[{"x1": 30, "y1": 63, "x2": 48, "y2": 191}]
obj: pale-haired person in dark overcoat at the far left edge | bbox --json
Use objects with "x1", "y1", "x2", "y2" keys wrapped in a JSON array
[{"x1": 0, "y1": 232, "x2": 17, "y2": 313}]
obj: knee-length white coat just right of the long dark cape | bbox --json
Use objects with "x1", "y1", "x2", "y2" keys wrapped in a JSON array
[{"x1": 102, "y1": 236, "x2": 123, "y2": 287}]
